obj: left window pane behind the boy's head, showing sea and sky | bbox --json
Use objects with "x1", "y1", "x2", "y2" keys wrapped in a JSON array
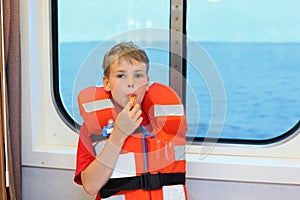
[{"x1": 54, "y1": 0, "x2": 170, "y2": 123}]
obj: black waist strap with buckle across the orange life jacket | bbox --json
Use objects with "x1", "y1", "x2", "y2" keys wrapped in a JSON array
[{"x1": 100, "y1": 172, "x2": 185, "y2": 198}]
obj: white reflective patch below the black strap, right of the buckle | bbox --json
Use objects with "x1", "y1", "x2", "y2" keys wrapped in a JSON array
[{"x1": 162, "y1": 185, "x2": 185, "y2": 200}]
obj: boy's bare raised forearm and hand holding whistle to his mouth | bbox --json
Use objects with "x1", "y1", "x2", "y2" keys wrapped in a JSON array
[{"x1": 81, "y1": 101, "x2": 143, "y2": 195}]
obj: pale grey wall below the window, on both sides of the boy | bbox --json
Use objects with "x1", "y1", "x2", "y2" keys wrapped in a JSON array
[{"x1": 22, "y1": 167, "x2": 300, "y2": 200}]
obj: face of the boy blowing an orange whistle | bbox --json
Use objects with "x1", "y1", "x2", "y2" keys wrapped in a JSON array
[{"x1": 103, "y1": 58, "x2": 149, "y2": 108}]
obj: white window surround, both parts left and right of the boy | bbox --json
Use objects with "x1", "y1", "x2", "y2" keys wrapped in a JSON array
[{"x1": 20, "y1": 0, "x2": 300, "y2": 184}]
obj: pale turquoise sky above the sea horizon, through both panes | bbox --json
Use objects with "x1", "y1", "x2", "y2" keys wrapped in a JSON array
[{"x1": 59, "y1": 0, "x2": 300, "y2": 42}]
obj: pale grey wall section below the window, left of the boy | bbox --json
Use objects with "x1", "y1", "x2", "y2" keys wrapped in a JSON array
[{"x1": 22, "y1": 167, "x2": 95, "y2": 200}]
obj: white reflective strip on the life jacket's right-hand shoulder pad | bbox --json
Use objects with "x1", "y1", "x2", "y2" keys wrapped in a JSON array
[{"x1": 154, "y1": 104, "x2": 184, "y2": 117}]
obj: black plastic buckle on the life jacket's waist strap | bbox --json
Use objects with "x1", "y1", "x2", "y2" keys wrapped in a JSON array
[{"x1": 141, "y1": 172, "x2": 162, "y2": 190}]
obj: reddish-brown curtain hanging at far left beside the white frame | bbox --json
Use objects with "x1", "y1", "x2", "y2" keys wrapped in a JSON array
[{"x1": 2, "y1": 0, "x2": 22, "y2": 199}]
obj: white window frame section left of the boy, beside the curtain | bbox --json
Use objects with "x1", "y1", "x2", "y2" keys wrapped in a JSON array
[{"x1": 20, "y1": 0, "x2": 78, "y2": 169}]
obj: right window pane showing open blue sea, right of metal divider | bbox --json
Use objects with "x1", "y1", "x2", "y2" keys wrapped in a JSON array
[{"x1": 187, "y1": 0, "x2": 300, "y2": 140}]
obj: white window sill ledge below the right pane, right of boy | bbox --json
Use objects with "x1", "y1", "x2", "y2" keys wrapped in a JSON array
[{"x1": 187, "y1": 151, "x2": 300, "y2": 184}]
